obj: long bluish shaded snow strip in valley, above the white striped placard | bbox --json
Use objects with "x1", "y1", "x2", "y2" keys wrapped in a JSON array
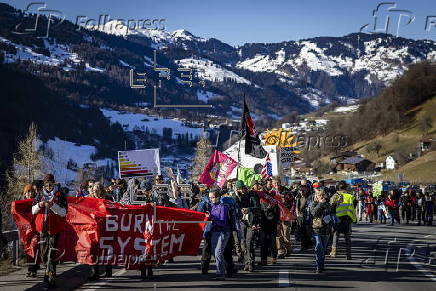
[{"x1": 100, "y1": 108, "x2": 202, "y2": 139}]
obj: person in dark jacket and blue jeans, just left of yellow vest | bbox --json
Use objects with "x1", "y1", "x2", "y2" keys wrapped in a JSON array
[{"x1": 309, "y1": 188, "x2": 332, "y2": 274}]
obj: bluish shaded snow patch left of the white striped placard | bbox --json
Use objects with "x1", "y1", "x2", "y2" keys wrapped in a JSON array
[{"x1": 40, "y1": 137, "x2": 116, "y2": 185}]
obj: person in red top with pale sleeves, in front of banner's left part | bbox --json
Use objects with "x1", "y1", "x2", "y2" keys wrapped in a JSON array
[{"x1": 32, "y1": 174, "x2": 67, "y2": 287}]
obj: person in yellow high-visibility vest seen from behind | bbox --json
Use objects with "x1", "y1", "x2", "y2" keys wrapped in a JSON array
[{"x1": 330, "y1": 181, "x2": 357, "y2": 260}]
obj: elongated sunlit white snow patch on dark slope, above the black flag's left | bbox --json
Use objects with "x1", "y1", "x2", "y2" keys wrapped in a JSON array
[{"x1": 175, "y1": 58, "x2": 251, "y2": 85}]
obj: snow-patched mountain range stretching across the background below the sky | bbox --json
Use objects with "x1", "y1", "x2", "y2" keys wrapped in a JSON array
[{"x1": 0, "y1": 5, "x2": 436, "y2": 119}]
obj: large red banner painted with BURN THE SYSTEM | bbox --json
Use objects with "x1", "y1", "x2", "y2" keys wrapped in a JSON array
[{"x1": 11, "y1": 197, "x2": 206, "y2": 269}]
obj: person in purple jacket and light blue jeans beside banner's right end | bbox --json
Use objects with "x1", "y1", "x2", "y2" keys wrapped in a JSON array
[{"x1": 209, "y1": 189, "x2": 232, "y2": 280}]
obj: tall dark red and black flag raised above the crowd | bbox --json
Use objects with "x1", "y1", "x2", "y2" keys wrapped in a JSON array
[{"x1": 241, "y1": 96, "x2": 266, "y2": 158}]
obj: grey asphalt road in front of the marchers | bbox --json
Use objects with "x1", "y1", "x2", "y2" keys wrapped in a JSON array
[{"x1": 78, "y1": 223, "x2": 436, "y2": 291}]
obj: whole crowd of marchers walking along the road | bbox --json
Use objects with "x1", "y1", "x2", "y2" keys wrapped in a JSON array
[{"x1": 10, "y1": 174, "x2": 436, "y2": 287}]
